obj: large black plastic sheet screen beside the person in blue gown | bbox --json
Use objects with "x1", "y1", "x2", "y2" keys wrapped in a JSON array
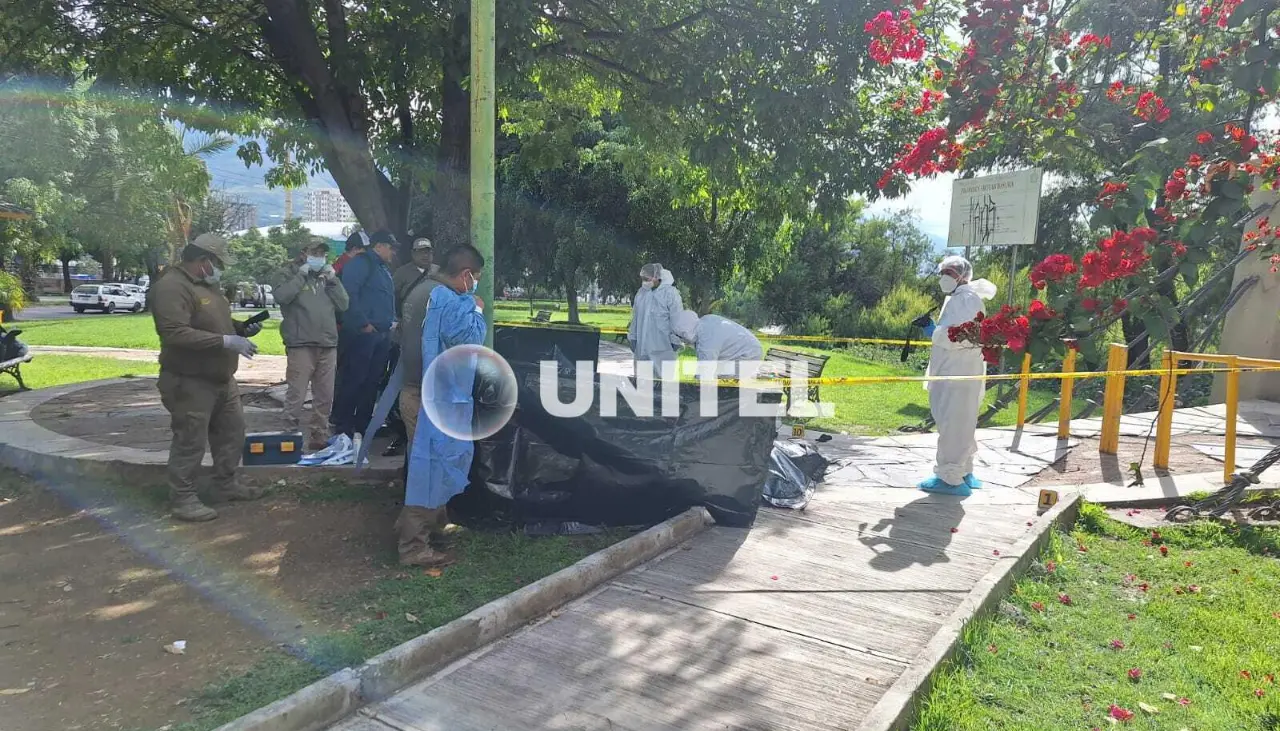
[{"x1": 465, "y1": 362, "x2": 782, "y2": 526}]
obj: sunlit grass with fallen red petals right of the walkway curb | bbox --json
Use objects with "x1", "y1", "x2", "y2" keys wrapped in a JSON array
[{"x1": 911, "y1": 506, "x2": 1280, "y2": 731}]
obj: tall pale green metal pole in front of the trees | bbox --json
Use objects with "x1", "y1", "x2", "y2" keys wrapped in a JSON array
[{"x1": 471, "y1": 0, "x2": 497, "y2": 347}]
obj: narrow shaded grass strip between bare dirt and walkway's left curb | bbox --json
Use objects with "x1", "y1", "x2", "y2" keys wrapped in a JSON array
[{"x1": 175, "y1": 533, "x2": 623, "y2": 731}]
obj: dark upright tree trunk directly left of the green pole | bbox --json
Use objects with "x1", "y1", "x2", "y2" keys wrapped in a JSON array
[{"x1": 431, "y1": 1, "x2": 471, "y2": 251}]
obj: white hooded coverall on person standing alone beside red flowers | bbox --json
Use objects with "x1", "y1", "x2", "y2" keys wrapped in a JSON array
[{"x1": 924, "y1": 273, "x2": 996, "y2": 485}]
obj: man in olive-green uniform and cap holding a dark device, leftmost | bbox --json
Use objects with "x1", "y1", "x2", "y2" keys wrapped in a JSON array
[{"x1": 148, "y1": 233, "x2": 262, "y2": 521}]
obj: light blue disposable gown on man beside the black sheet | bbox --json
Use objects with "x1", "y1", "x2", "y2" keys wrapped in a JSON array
[{"x1": 404, "y1": 287, "x2": 485, "y2": 508}]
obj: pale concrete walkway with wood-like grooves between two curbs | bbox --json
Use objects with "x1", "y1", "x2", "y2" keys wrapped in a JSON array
[{"x1": 333, "y1": 431, "x2": 1065, "y2": 731}]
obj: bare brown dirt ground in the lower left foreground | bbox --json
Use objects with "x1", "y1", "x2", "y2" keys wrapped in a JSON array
[{"x1": 0, "y1": 471, "x2": 396, "y2": 731}]
